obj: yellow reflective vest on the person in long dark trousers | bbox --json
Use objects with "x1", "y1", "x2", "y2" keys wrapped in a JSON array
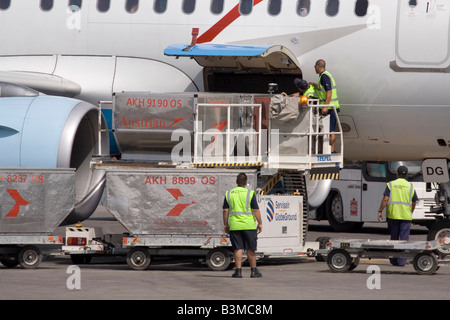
[{"x1": 386, "y1": 178, "x2": 414, "y2": 220}]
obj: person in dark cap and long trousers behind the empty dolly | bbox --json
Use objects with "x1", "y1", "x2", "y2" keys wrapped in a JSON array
[{"x1": 378, "y1": 166, "x2": 419, "y2": 266}]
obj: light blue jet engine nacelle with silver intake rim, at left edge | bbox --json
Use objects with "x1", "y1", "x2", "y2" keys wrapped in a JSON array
[{"x1": 0, "y1": 96, "x2": 109, "y2": 224}]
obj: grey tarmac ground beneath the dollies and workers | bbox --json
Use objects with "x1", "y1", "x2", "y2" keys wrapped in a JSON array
[{"x1": 0, "y1": 206, "x2": 450, "y2": 306}]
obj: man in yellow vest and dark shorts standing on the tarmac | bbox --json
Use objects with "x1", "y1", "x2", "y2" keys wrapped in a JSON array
[{"x1": 223, "y1": 173, "x2": 262, "y2": 278}]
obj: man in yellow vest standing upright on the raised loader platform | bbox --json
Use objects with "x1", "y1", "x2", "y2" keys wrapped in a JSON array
[{"x1": 310, "y1": 59, "x2": 340, "y2": 153}]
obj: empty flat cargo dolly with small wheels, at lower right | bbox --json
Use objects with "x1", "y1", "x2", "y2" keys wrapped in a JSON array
[{"x1": 327, "y1": 238, "x2": 450, "y2": 274}]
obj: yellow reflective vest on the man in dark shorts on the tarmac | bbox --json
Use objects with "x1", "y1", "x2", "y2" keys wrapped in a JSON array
[{"x1": 225, "y1": 187, "x2": 256, "y2": 230}]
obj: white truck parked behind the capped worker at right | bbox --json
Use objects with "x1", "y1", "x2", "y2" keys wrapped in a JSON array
[{"x1": 309, "y1": 161, "x2": 434, "y2": 232}]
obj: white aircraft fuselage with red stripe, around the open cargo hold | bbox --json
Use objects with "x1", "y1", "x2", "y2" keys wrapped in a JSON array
[{"x1": 0, "y1": 0, "x2": 450, "y2": 160}]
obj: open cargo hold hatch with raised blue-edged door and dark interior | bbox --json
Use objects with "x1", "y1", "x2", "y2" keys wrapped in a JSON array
[{"x1": 164, "y1": 44, "x2": 302, "y2": 93}]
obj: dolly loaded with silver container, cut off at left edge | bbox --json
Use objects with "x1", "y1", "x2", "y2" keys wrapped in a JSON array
[{"x1": 0, "y1": 168, "x2": 75, "y2": 269}]
